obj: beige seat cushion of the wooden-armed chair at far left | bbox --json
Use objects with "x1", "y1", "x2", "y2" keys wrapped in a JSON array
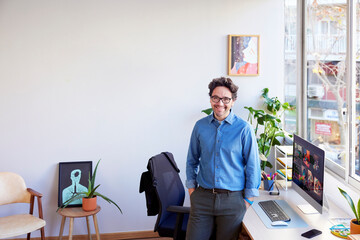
[{"x1": 0, "y1": 214, "x2": 46, "y2": 238}]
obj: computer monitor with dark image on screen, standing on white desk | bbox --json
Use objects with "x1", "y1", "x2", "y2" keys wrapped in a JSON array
[{"x1": 292, "y1": 135, "x2": 325, "y2": 214}]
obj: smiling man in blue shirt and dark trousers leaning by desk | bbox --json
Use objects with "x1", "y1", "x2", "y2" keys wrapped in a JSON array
[{"x1": 186, "y1": 77, "x2": 261, "y2": 240}]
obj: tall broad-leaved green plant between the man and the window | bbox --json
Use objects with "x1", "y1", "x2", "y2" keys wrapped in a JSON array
[{"x1": 245, "y1": 88, "x2": 295, "y2": 170}]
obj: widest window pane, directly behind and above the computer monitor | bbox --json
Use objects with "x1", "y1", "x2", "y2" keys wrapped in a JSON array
[{"x1": 306, "y1": 0, "x2": 348, "y2": 167}]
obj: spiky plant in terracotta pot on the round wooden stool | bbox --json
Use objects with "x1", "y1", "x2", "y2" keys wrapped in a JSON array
[{"x1": 56, "y1": 159, "x2": 122, "y2": 213}]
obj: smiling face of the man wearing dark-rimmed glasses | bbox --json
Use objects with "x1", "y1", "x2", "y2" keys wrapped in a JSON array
[{"x1": 210, "y1": 87, "x2": 235, "y2": 121}]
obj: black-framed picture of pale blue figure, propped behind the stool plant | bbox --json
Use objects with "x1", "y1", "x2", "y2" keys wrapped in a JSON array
[{"x1": 58, "y1": 161, "x2": 92, "y2": 207}]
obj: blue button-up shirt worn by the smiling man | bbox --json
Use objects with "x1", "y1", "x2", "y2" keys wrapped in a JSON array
[{"x1": 186, "y1": 111, "x2": 261, "y2": 198}]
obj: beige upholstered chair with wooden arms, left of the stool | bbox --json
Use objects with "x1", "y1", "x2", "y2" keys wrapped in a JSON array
[{"x1": 0, "y1": 172, "x2": 46, "y2": 240}]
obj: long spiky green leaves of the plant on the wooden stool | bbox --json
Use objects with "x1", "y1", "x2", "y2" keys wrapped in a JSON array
[{"x1": 56, "y1": 159, "x2": 122, "y2": 213}]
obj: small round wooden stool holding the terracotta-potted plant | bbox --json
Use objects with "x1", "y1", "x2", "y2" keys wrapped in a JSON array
[{"x1": 58, "y1": 206, "x2": 101, "y2": 240}]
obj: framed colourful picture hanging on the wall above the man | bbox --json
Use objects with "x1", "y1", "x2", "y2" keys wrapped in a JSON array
[{"x1": 228, "y1": 35, "x2": 260, "y2": 76}]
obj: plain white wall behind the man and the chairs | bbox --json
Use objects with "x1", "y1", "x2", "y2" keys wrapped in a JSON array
[{"x1": 0, "y1": 0, "x2": 284, "y2": 236}]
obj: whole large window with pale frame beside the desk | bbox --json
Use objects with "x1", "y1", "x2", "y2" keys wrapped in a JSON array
[{"x1": 284, "y1": 0, "x2": 360, "y2": 185}]
